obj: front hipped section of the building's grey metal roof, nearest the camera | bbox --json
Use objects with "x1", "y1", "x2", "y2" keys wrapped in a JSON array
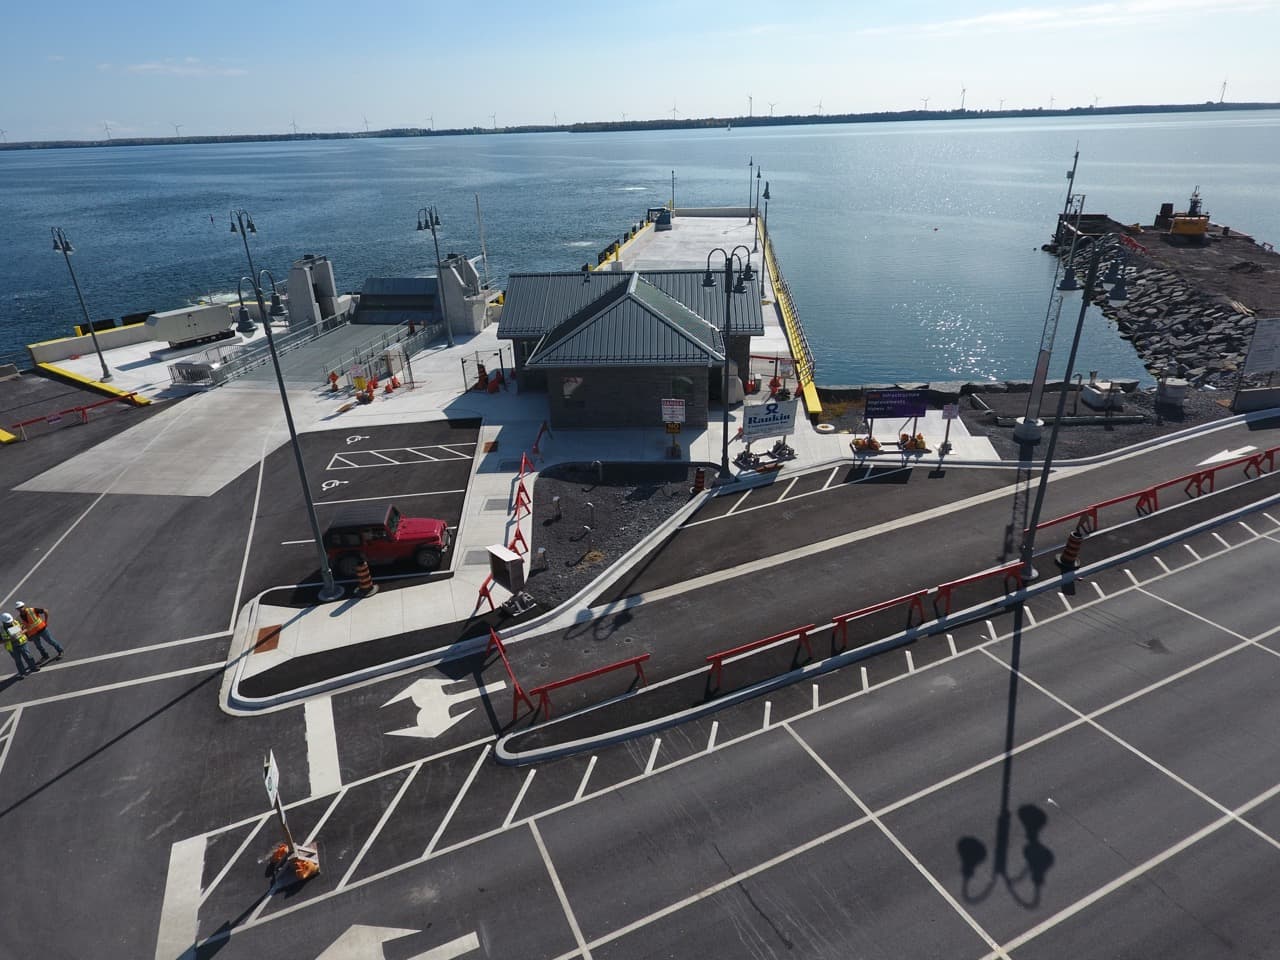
[{"x1": 526, "y1": 274, "x2": 724, "y2": 369}]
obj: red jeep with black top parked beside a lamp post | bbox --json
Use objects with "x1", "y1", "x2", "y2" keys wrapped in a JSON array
[{"x1": 324, "y1": 503, "x2": 452, "y2": 577}]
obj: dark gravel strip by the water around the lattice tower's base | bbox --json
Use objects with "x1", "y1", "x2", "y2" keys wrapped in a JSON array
[{"x1": 960, "y1": 389, "x2": 1231, "y2": 460}]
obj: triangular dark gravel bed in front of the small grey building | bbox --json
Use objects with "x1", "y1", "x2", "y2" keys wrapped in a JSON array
[{"x1": 527, "y1": 463, "x2": 716, "y2": 609}]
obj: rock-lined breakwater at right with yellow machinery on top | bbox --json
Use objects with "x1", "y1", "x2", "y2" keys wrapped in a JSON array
[{"x1": 1044, "y1": 192, "x2": 1280, "y2": 389}]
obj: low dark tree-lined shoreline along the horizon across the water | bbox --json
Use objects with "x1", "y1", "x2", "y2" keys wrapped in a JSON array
[{"x1": 0, "y1": 101, "x2": 1280, "y2": 150}]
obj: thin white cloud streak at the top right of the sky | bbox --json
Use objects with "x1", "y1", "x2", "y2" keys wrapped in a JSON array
[{"x1": 859, "y1": 0, "x2": 1280, "y2": 36}]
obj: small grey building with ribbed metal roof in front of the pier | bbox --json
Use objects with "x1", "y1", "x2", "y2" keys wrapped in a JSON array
[{"x1": 498, "y1": 264, "x2": 763, "y2": 428}]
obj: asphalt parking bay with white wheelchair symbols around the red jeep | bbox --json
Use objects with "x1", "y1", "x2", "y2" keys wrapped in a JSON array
[{"x1": 244, "y1": 420, "x2": 480, "y2": 602}]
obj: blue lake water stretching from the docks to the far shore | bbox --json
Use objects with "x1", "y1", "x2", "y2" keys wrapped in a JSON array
[{"x1": 0, "y1": 111, "x2": 1280, "y2": 384}]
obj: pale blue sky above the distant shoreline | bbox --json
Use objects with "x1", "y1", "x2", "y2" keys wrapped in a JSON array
[{"x1": 0, "y1": 0, "x2": 1280, "y2": 142}]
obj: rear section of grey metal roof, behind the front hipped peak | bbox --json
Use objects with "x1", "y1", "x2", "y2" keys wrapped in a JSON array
[{"x1": 498, "y1": 269, "x2": 764, "y2": 339}]
